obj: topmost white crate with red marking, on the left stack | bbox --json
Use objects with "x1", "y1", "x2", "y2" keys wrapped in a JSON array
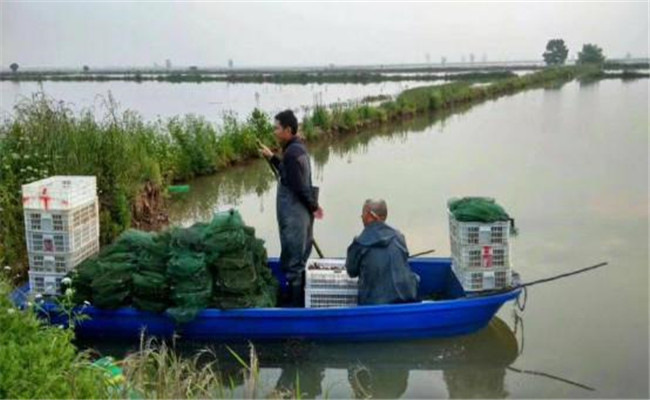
[{"x1": 22, "y1": 176, "x2": 97, "y2": 211}]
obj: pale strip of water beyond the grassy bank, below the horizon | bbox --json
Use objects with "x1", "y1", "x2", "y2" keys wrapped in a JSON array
[{"x1": 0, "y1": 81, "x2": 436, "y2": 122}]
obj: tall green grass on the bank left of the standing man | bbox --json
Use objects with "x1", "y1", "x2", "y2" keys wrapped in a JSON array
[{"x1": 0, "y1": 93, "x2": 274, "y2": 280}]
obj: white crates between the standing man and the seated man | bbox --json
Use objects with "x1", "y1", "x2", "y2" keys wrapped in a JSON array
[{"x1": 305, "y1": 259, "x2": 359, "y2": 308}]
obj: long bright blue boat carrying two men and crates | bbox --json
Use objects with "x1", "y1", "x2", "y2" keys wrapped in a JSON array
[{"x1": 14, "y1": 258, "x2": 521, "y2": 341}]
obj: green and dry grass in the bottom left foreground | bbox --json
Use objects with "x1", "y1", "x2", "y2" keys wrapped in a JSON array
[{"x1": 0, "y1": 272, "x2": 301, "y2": 399}]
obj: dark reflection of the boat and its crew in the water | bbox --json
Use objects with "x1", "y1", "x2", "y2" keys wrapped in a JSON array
[{"x1": 230, "y1": 318, "x2": 518, "y2": 398}]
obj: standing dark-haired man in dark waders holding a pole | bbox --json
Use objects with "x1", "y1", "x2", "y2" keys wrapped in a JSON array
[{"x1": 260, "y1": 110, "x2": 323, "y2": 307}]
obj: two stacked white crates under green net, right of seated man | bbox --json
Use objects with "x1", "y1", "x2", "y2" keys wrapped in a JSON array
[{"x1": 448, "y1": 210, "x2": 512, "y2": 292}]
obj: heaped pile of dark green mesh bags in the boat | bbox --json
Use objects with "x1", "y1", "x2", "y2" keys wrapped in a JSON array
[{"x1": 72, "y1": 210, "x2": 278, "y2": 323}]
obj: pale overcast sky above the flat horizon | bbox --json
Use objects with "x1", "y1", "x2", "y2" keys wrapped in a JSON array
[{"x1": 0, "y1": 0, "x2": 648, "y2": 68}]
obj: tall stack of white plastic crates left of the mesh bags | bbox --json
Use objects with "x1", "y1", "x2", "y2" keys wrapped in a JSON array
[{"x1": 22, "y1": 176, "x2": 99, "y2": 295}]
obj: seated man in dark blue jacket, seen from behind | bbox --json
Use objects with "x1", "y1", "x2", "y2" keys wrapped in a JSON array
[{"x1": 345, "y1": 200, "x2": 418, "y2": 305}]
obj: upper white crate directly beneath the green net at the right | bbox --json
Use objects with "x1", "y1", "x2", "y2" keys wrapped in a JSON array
[{"x1": 447, "y1": 210, "x2": 510, "y2": 246}]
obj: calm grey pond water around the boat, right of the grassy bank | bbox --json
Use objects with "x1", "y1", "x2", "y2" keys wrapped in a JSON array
[{"x1": 161, "y1": 80, "x2": 649, "y2": 398}]
